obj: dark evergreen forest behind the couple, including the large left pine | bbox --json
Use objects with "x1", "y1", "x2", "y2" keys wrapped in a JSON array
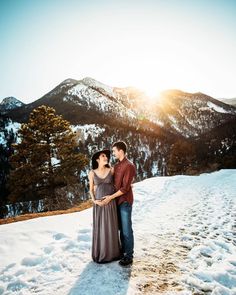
[{"x1": 0, "y1": 105, "x2": 236, "y2": 218}]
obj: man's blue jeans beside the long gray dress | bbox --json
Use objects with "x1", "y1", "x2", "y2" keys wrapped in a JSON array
[{"x1": 117, "y1": 201, "x2": 134, "y2": 258}]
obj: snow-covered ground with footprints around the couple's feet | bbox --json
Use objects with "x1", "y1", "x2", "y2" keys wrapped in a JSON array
[{"x1": 0, "y1": 170, "x2": 236, "y2": 295}]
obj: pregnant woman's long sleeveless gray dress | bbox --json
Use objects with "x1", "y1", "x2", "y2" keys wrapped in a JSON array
[{"x1": 92, "y1": 170, "x2": 121, "y2": 263}]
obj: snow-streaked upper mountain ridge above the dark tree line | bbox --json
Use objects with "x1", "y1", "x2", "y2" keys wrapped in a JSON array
[{"x1": 4, "y1": 77, "x2": 236, "y2": 138}]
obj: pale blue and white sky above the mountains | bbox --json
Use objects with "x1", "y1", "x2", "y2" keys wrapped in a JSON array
[{"x1": 0, "y1": 0, "x2": 236, "y2": 103}]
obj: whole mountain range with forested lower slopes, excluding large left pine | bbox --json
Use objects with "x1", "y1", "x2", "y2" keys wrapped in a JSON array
[{"x1": 0, "y1": 78, "x2": 236, "y2": 217}]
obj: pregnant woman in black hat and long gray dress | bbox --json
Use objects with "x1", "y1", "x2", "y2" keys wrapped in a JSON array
[{"x1": 89, "y1": 149, "x2": 121, "y2": 263}]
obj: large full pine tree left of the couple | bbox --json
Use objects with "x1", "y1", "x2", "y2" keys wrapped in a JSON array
[{"x1": 9, "y1": 105, "x2": 87, "y2": 208}]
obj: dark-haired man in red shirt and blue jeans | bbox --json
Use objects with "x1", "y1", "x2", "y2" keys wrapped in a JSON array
[{"x1": 103, "y1": 141, "x2": 136, "y2": 266}]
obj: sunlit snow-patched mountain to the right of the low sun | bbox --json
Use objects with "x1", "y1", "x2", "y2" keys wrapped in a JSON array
[{"x1": 152, "y1": 90, "x2": 236, "y2": 137}]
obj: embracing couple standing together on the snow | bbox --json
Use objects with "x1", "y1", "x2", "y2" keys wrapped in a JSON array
[{"x1": 89, "y1": 141, "x2": 136, "y2": 266}]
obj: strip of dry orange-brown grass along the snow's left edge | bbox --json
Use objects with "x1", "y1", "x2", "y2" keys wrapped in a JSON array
[{"x1": 0, "y1": 200, "x2": 93, "y2": 224}]
